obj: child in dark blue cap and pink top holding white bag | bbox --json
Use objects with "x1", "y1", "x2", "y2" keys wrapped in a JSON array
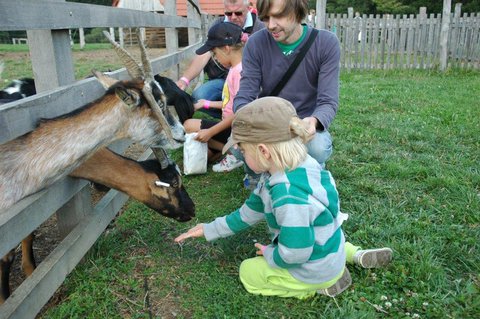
[{"x1": 183, "y1": 22, "x2": 243, "y2": 172}]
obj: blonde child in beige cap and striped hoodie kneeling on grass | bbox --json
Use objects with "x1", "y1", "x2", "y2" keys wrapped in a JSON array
[{"x1": 175, "y1": 97, "x2": 392, "y2": 299}]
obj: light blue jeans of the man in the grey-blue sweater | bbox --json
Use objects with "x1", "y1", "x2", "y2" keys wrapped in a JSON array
[{"x1": 229, "y1": 131, "x2": 333, "y2": 178}]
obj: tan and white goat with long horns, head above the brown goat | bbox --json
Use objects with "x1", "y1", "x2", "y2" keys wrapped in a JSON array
[{"x1": 0, "y1": 30, "x2": 185, "y2": 304}]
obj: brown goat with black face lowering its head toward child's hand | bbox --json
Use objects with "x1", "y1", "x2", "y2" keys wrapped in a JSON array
[{"x1": 0, "y1": 148, "x2": 195, "y2": 304}]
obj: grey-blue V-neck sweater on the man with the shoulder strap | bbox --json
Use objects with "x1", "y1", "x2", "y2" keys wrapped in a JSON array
[{"x1": 234, "y1": 27, "x2": 340, "y2": 129}]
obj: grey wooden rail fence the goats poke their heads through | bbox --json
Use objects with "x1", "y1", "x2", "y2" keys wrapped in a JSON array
[{"x1": 0, "y1": 0, "x2": 210, "y2": 319}]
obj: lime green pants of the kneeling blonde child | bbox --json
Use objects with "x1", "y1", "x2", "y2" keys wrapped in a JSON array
[{"x1": 239, "y1": 242, "x2": 360, "y2": 299}]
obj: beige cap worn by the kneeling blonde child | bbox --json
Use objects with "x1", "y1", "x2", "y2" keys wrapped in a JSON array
[{"x1": 223, "y1": 96, "x2": 297, "y2": 153}]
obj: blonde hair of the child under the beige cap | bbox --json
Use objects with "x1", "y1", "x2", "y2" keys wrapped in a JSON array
[{"x1": 240, "y1": 117, "x2": 313, "y2": 171}]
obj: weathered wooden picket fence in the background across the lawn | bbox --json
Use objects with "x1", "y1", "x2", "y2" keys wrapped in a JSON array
[{"x1": 325, "y1": 4, "x2": 480, "y2": 70}]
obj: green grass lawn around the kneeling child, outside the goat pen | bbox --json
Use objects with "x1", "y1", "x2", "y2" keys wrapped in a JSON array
[{"x1": 35, "y1": 71, "x2": 480, "y2": 318}]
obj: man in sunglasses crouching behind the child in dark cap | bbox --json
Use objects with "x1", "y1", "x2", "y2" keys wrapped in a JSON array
[{"x1": 177, "y1": 0, "x2": 265, "y2": 118}]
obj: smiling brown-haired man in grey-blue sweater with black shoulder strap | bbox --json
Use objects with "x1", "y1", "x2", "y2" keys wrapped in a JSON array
[{"x1": 234, "y1": 0, "x2": 340, "y2": 186}]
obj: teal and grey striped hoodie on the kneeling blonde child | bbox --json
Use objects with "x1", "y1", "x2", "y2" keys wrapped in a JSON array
[{"x1": 204, "y1": 156, "x2": 348, "y2": 284}]
